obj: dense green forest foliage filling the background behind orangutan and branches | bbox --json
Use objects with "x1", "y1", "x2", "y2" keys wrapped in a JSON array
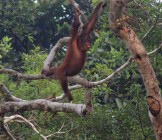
[{"x1": 0, "y1": 0, "x2": 162, "y2": 140}]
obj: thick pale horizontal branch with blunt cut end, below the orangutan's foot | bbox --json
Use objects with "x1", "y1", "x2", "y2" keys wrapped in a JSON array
[{"x1": 0, "y1": 99, "x2": 86, "y2": 116}]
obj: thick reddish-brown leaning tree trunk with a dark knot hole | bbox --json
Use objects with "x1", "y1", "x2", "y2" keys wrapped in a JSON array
[{"x1": 110, "y1": 0, "x2": 162, "y2": 140}]
